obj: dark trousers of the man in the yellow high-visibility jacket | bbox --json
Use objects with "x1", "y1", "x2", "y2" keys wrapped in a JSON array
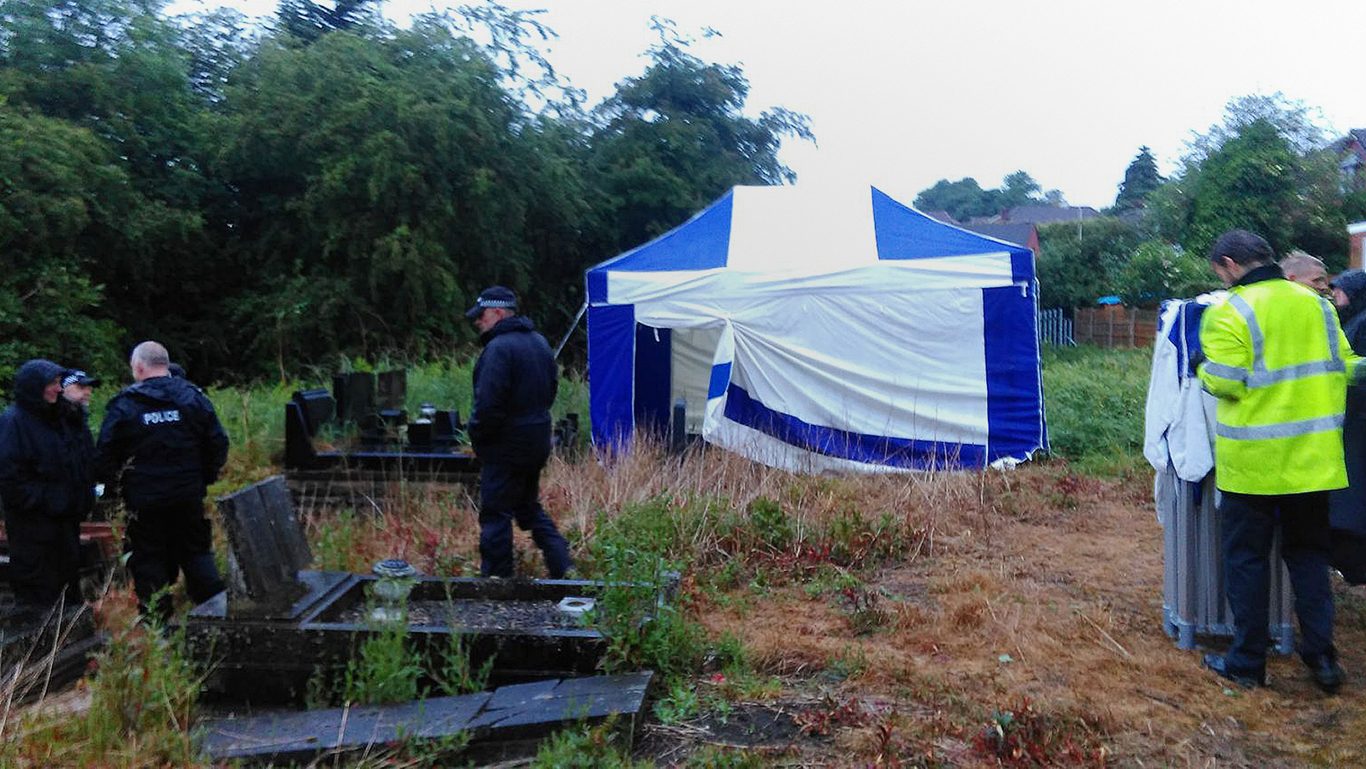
[{"x1": 1220, "y1": 492, "x2": 1336, "y2": 676}]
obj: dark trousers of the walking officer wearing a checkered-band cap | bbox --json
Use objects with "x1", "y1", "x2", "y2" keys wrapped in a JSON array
[{"x1": 479, "y1": 462, "x2": 574, "y2": 579}]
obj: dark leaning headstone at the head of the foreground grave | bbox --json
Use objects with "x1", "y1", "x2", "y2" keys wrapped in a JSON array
[{"x1": 219, "y1": 475, "x2": 313, "y2": 617}]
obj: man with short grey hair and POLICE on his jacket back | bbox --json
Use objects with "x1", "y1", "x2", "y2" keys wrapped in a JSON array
[{"x1": 97, "y1": 341, "x2": 228, "y2": 619}]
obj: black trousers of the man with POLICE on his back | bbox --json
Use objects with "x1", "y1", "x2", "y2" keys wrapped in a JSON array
[{"x1": 124, "y1": 500, "x2": 225, "y2": 619}]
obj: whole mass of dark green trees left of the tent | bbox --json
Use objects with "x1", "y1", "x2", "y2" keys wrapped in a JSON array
[{"x1": 0, "y1": 0, "x2": 810, "y2": 377}]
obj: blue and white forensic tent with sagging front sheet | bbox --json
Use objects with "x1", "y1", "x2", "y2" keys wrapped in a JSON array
[{"x1": 587, "y1": 186, "x2": 1048, "y2": 473}]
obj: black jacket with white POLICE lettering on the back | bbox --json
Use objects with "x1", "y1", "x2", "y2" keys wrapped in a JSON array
[{"x1": 96, "y1": 377, "x2": 228, "y2": 509}]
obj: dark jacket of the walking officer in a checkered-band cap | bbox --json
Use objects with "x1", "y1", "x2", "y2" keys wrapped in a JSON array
[{"x1": 470, "y1": 316, "x2": 560, "y2": 464}]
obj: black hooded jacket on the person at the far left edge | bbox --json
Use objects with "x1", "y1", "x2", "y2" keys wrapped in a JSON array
[{"x1": 0, "y1": 361, "x2": 94, "y2": 522}]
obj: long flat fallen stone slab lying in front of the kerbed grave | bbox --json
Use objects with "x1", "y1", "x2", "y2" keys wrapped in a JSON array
[{"x1": 199, "y1": 671, "x2": 654, "y2": 765}]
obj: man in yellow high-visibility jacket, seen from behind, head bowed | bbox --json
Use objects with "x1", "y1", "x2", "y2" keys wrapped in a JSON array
[{"x1": 1198, "y1": 229, "x2": 1359, "y2": 693}]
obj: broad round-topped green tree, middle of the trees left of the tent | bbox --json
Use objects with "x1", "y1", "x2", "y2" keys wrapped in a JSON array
[{"x1": 219, "y1": 16, "x2": 587, "y2": 367}]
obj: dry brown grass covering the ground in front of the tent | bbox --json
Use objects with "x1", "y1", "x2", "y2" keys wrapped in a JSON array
[{"x1": 10, "y1": 447, "x2": 1366, "y2": 768}]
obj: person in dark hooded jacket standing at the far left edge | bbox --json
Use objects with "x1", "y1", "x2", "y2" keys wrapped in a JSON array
[{"x1": 0, "y1": 359, "x2": 94, "y2": 611}]
